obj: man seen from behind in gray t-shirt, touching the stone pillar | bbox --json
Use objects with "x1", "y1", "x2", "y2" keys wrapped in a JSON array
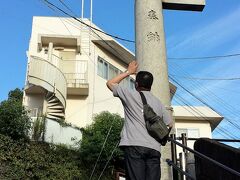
[{"x1": 107, "y1": 61, "x2": 172, "y2": 180}]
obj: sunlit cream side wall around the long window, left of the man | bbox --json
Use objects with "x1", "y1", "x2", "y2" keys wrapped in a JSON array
[{"x1": 89, "y1": 45, "x2": 126, "y2": 122}]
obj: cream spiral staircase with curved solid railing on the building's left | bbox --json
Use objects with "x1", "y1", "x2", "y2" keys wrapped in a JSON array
[{"x1": 25, "y1": 56, "x2": 67, "y2": 120}]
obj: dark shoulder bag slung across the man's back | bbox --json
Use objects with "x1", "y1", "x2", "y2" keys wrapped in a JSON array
[{"x1": 139, "y1": 92, "x2": 171, "y2": 146}]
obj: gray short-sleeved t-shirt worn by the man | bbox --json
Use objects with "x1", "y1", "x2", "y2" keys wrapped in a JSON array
[{"x1": 113, "y1": 84, "x2": 172, "y2": 151}]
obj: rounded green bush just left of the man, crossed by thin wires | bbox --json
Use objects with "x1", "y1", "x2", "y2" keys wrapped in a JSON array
[{"x1": 80, "y1": 112, "x2": 123, "y2": 179}]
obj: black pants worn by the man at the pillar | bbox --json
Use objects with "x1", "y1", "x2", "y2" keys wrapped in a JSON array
[{"x1": 121, "y1": 146, "x2": 161, "y2": 180}]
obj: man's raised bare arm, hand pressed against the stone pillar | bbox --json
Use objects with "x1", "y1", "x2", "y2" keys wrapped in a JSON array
[{"x1": 107, "y1": 61, "x2": 138, "y2": 91}]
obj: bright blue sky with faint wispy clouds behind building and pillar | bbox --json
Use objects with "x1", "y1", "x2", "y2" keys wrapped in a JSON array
[{"x1": 0, "y1": 0, "x2": 240, "y2": 146}]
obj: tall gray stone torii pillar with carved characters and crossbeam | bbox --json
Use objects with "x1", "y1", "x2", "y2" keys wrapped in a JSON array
[{"x1": 135, "y1": 0, "x2": 205, "y2": 180}]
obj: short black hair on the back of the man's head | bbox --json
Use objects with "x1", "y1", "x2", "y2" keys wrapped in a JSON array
[{"x1": 136, "y1": 71, "x2": 153, "y2": 90}]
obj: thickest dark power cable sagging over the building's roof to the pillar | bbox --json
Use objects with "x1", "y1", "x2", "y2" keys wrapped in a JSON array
[{"x1": 42, "y1": 0, "x2": 135, "y2": 43}]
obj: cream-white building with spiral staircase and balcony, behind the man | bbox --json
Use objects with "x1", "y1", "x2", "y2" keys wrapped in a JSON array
[{"x1": 24, "y1": 17, "x2": 222, "y2": 148}]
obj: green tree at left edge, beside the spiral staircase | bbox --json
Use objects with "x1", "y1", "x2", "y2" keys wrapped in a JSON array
[{"x1": 0, "y1": 88, "x2": 31, "y2": 139}]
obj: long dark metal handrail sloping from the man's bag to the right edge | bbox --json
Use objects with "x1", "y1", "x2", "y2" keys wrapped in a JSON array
[{"x1": 168, "y1": 137, "x2": 240, "y2": 177}]
